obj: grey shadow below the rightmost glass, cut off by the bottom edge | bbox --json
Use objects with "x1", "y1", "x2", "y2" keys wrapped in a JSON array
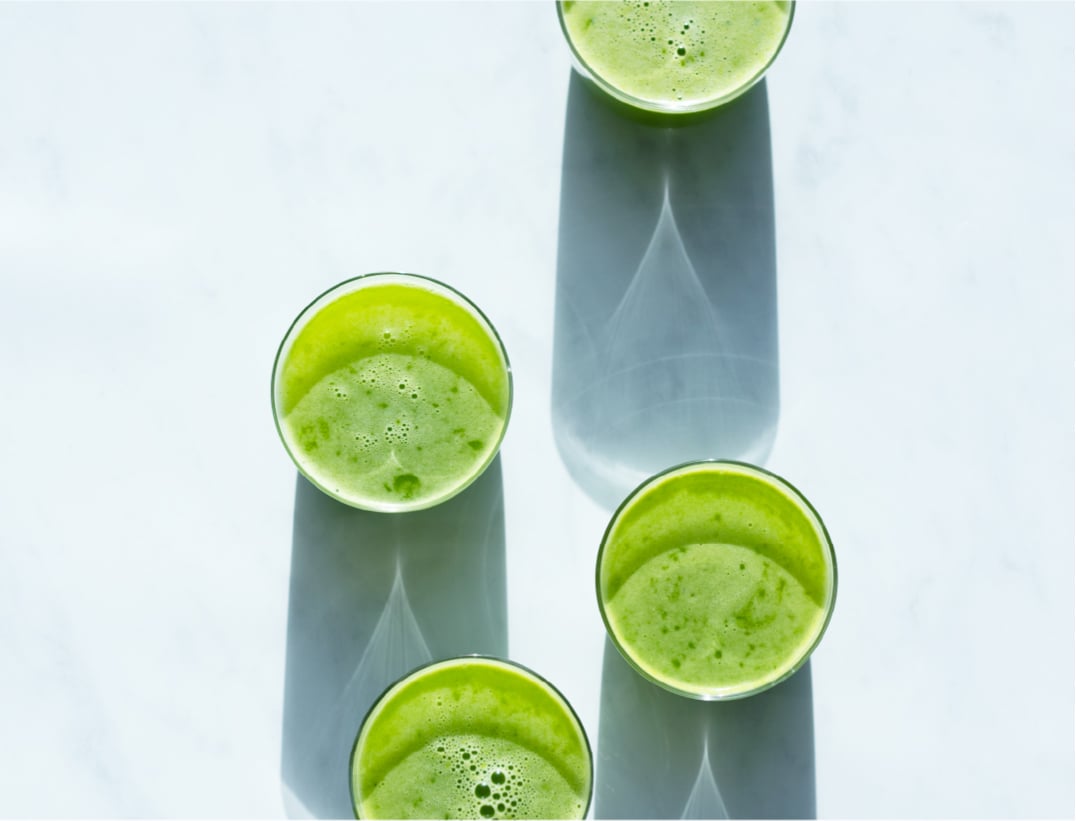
[{"x1": 594, "y1": 640, "x2": 816, "y2": 818}]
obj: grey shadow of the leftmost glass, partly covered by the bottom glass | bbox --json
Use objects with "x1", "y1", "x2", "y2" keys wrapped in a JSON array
[{"x1": 281, "y1": 456, "x2": 508, "y2": 818}]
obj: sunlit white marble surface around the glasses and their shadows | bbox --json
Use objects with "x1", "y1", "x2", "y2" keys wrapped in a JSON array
[{"x1": 0, "y1": 2, "x2": 1074, "y2": 818}]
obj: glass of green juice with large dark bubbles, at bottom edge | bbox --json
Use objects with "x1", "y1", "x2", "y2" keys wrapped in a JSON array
[{"x1": 351, "y1": 656, "x2": 592, "y2": 819}]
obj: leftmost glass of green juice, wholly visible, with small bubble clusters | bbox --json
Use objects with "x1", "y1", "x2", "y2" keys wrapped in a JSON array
[{"x1": 272, "y1": 273, "x2": 512, "y2": 512}]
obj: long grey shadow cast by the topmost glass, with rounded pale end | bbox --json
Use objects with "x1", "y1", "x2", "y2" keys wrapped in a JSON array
[{"x1": 552, "y1": 72, "x2": 778, "y2": 508}]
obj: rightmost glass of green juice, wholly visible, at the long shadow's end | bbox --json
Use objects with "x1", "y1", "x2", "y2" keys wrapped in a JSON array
[{"x1": 596, "y1": 461, "x2": 837, "y2": 700}]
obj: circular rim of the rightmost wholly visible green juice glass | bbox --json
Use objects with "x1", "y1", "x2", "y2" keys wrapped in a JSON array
[{"x1": 594, "y1": 458, "x2": 837, "y2": 702}]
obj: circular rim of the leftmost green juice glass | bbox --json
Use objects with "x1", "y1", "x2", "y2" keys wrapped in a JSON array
[{"x1": 269, "y1": 271, "x2": 515, "y2": 513}]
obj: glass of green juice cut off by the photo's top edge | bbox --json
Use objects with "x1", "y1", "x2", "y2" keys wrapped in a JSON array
[{"x1": 557, "y1": 0, "x2": 793, "y2": 112}]
